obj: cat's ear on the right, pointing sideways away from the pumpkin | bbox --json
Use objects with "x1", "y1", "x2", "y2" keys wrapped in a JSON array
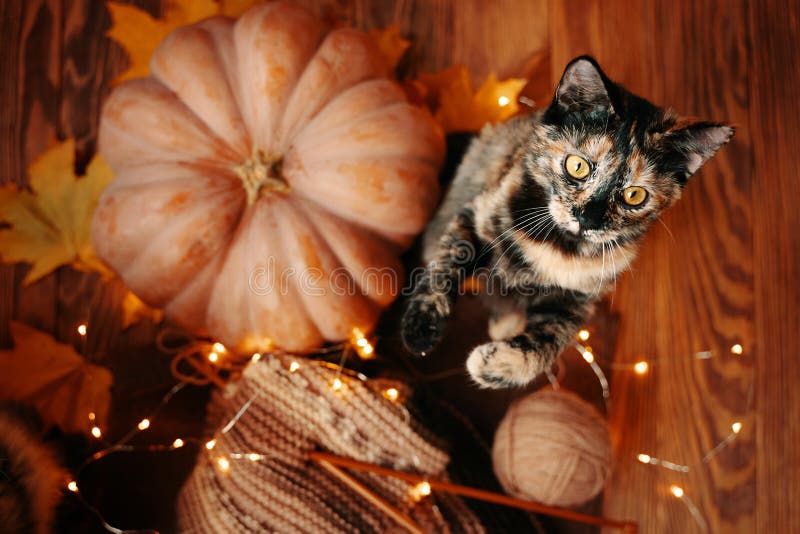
[{"x1": 660, "y1": 120, "x2": 734, "y2": 183}]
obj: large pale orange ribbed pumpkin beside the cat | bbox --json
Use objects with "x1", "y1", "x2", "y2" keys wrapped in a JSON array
[{"x1": 93, "y1": 3, "x2": 444, "y2": 358}]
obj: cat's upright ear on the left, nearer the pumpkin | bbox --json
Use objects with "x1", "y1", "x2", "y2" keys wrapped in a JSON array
[{"x1": 553, "y1": 56, "x2": 614, "y2": 117}]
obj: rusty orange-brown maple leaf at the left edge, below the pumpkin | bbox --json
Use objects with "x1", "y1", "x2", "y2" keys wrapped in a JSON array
[{"x1": 0, "y1": 321, "x2": 112, "y2": 438}]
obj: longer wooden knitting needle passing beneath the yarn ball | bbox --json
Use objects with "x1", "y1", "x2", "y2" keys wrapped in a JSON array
[{"x1": 310, "y1": 451, "x2": 639, "y2": 534}]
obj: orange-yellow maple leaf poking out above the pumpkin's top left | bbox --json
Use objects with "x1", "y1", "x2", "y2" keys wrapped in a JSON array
[{"x1": 106, "y1": 0, "x2": 222, "y2": 84}]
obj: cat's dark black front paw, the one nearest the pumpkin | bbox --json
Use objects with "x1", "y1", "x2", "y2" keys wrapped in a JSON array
[{"x1": 400, "y1": 293, "x2": 450, "y2": 354}]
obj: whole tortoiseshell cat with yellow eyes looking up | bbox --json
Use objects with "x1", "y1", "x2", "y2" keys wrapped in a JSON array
[{"x1": 402, "y1": 56, "x2": 733, "y2": 388}]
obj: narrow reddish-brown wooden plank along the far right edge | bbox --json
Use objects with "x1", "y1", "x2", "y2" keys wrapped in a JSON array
[{"x1": 748, "y1": 0, "x2": 800, "y2": 532}]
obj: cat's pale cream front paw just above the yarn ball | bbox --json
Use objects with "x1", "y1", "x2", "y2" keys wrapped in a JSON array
[{"x1": 467, "y1": 341, "x2": 547, "y2": 389}]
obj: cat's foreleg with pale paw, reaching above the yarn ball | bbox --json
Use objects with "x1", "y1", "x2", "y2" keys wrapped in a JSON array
[{"x1": 467, "y1": 294, "x2": 593, "y2": 388}]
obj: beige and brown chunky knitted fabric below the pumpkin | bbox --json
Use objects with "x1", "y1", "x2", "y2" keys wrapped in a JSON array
[{"x1": 178, "y1": 356, "x2": 484, "y2": 534}]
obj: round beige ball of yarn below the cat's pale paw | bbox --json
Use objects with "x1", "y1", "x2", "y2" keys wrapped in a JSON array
[{"x1": 492, "y1": 389, "x2": 611, "y2": 507}]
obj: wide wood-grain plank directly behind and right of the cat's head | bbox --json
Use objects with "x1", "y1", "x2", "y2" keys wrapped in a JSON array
[{"x1": 551, "y1": 1, "x2": 755, "y2": 532}]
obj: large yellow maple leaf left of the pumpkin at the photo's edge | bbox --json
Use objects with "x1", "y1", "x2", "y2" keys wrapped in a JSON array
[{"x1": 0, "y1": 139, "x2": 113, "y2": 285}]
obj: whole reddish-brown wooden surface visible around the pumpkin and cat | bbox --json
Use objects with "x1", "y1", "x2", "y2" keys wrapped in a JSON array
[{"x1": 0, "y1": 0, "x2": 800, "y2": 533}]
